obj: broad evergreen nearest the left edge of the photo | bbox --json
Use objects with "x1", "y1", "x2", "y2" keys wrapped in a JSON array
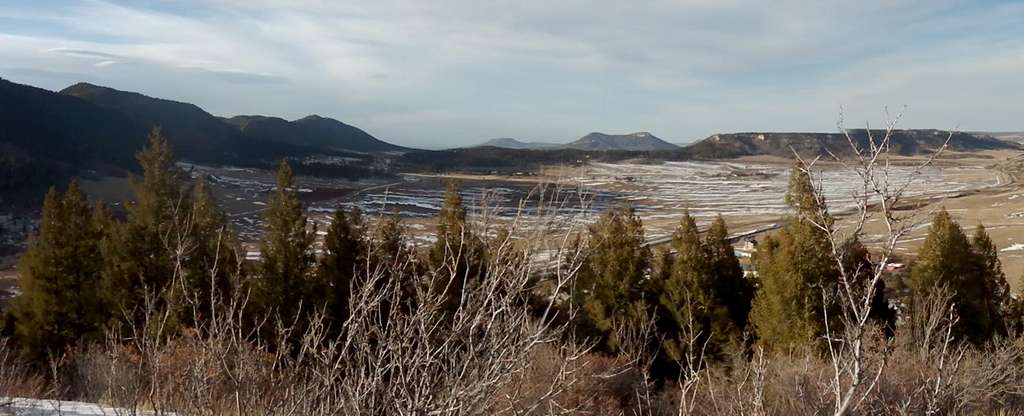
[{"x1": 12, "y1": 182, "x2": 110, "y2": 362}]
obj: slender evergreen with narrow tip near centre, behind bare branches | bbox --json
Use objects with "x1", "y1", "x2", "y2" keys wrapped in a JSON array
[{"x1": 428, "y1": 181, "x2": 486, "y2": 315}]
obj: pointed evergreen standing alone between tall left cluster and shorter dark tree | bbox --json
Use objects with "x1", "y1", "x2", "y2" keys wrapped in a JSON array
[{"x1": 256, "y1": 161, "x2": 323, "y2": 333}]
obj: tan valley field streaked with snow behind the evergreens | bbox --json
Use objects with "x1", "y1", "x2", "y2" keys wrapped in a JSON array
[{"x1": 12, "y1": 152, "x2": 1024, "y2": 285}]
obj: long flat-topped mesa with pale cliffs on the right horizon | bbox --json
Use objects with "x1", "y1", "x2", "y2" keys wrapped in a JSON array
[{"x1": 684, "y1": 129, "x2": 1021, "y2": 159}]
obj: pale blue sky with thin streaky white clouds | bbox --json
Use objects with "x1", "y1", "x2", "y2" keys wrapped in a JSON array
[{"x1": 0, "y1": 0, "x2": 1024, "y2": 149}]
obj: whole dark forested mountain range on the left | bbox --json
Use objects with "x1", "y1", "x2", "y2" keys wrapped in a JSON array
[{"x1": 0, "y1": 79, "x2": 408, "y2": 191}]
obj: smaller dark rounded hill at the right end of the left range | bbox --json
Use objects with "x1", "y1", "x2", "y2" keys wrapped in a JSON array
[{"x1": 225, "y1": 115, "x2": 408, "y2": 153}]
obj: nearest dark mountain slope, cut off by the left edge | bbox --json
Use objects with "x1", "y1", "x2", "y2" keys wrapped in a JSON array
[{"x1": 0, "y1": 79, "x2": 147, "y2": 190}]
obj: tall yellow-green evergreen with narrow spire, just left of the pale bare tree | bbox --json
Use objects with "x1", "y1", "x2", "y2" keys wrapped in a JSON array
[{"x1": 751, "y1": 160, "x2": 838, "y2": 351}]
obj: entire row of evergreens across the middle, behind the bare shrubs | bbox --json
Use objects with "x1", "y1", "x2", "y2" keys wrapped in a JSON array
[{"x1": 3, "y1": 130, "x2": 1021, "y2": 379}]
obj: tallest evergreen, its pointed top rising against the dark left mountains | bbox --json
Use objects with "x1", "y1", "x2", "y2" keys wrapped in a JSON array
[{"x1": 101, "y1": 129, "x2": 188, "y2": 326}]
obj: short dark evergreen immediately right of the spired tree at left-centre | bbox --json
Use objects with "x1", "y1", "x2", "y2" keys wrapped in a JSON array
[{"x1": 316, "y1": 209, "x2": 368, "y2": 333}]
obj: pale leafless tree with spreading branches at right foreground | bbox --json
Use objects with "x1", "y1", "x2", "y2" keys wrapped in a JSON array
[{"x1": 794, "y1": 109, "x2": 952, "y2": 415}]
